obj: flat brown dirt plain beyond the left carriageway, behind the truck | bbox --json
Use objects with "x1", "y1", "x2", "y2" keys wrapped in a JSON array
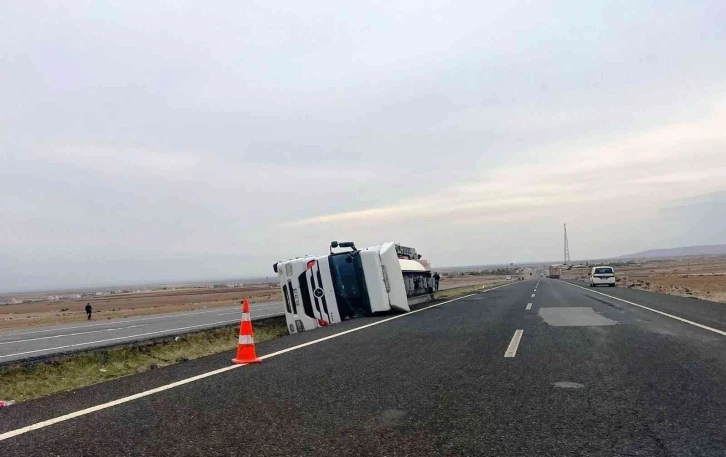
[{"x1": 0, "y1": 276, "x2": 502, "y2": 330}]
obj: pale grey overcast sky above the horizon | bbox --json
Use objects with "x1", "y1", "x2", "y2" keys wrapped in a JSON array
[{"x1": 0, "y1": 0, "x2": 726, "y2": 291}]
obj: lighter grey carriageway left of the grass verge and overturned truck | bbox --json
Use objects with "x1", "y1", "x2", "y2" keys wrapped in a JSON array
[{"x1": 0, "y1": 302, "x2": 284, "y2": 363}]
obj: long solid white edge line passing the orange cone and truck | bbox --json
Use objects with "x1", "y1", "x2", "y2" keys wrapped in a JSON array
[{"x1": 0, "y1": 284, "x2": 511, "y2": 441}]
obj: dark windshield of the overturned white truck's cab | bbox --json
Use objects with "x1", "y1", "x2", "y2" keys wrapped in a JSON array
[{"x1": 328, "y1": 254, "x2": 371, "y2": 318}]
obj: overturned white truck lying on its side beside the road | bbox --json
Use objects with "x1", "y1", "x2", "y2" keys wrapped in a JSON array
[{"x1": 273, "y1": 241, "x2": 434, "y2": 333}]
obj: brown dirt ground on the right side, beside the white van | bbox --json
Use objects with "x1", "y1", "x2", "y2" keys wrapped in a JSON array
[{"x1": 562, "y1": 256, "x2": 726, "y2": 303}]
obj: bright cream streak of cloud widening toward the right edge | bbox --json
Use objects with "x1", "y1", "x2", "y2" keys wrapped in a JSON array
[{"x1": 284, "y1": 106, "x2": 726, "y2": 226}]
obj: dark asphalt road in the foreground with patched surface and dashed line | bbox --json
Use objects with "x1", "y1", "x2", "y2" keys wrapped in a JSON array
[{"x1": 0, "y1": 279, "x2": 726, "y2": 457}]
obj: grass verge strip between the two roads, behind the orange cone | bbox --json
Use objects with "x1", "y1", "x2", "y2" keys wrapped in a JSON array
[{"x1": 0, "y1": 317, "x2": 287, "y2": 401}]
